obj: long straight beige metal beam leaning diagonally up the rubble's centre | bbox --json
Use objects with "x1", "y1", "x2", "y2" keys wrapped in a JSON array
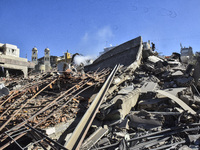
[{"x1": 65, "y1": 65, "x2": 119, "y2": 150}]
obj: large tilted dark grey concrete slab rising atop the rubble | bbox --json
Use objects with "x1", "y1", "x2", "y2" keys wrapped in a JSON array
[{"x1": 85, "y1": 36, "x2": 142, "y2": 71}]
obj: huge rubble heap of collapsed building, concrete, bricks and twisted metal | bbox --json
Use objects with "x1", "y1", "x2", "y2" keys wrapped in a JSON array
[{"x1": 0, "y1": 37, "x2": 200, "y2": 150}]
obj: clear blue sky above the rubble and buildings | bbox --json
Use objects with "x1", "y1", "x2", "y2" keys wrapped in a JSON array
[{"x1": 0, "y1": 0, "x2": 200, "y2": 60}]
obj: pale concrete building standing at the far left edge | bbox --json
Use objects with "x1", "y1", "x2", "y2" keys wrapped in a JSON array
[{"x1": 0, "y1": 43, "x2": 35, "y2": 77}]
